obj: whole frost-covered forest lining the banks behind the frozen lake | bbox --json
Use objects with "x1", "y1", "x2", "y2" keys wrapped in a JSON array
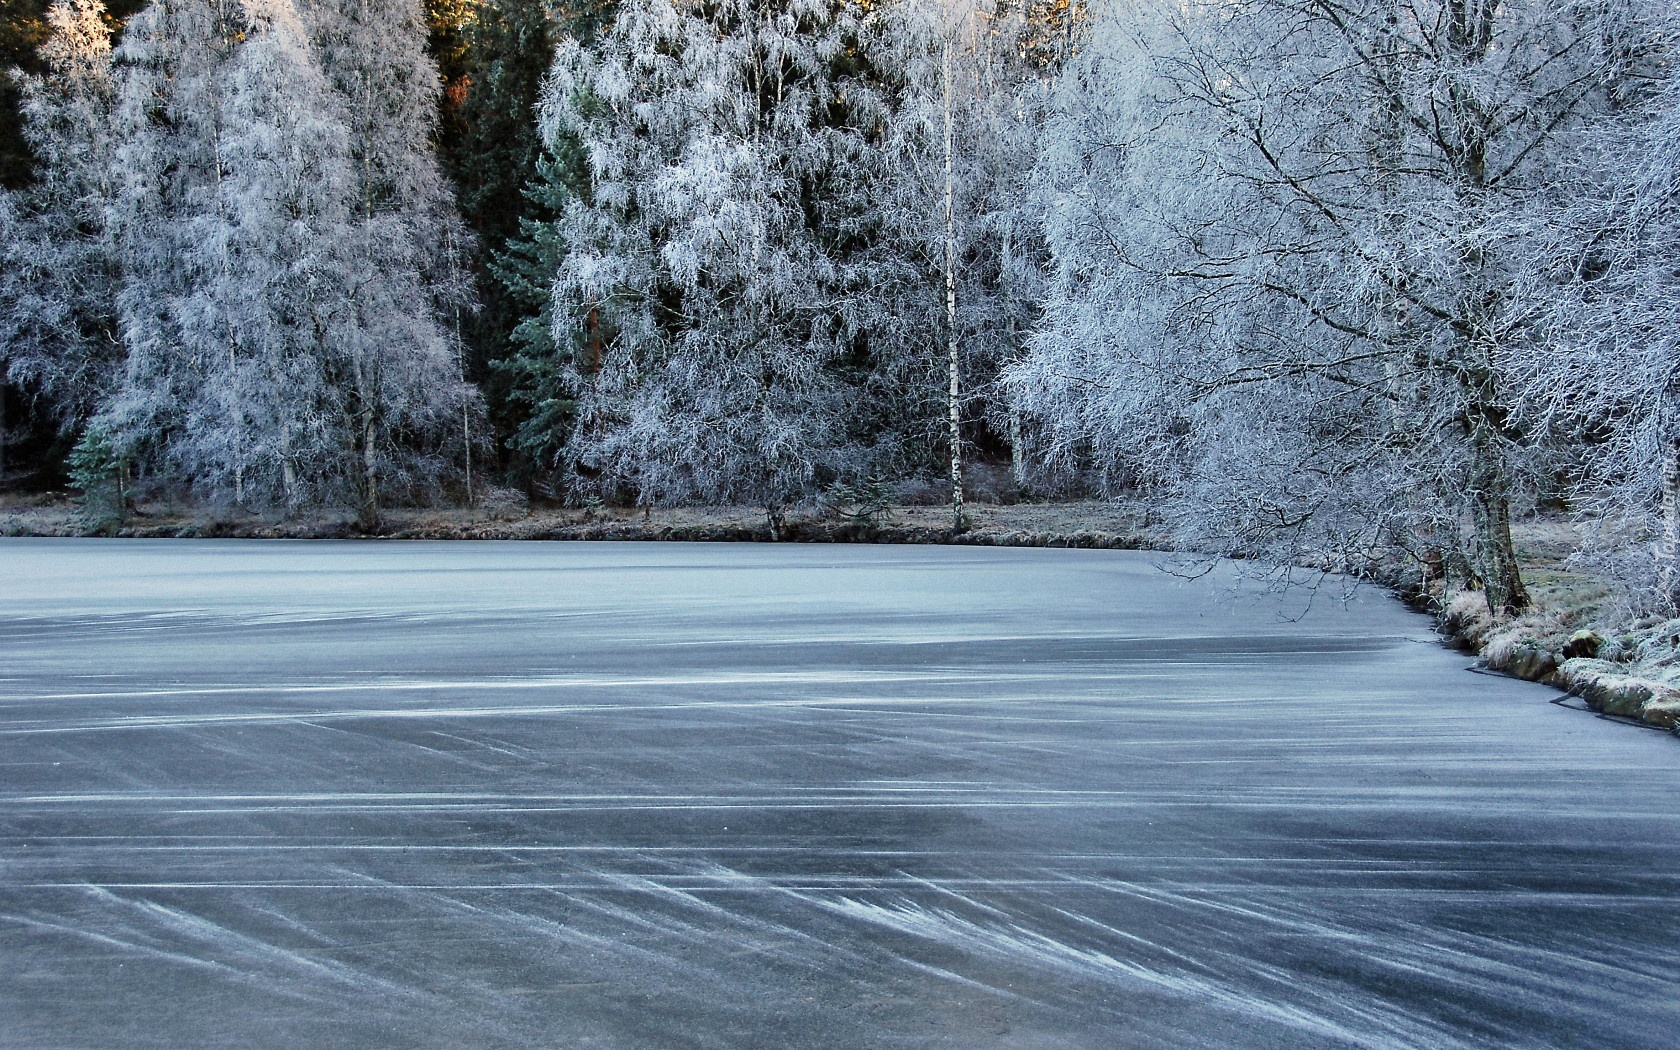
[{"x1": 0, "y1": 0, "x2": 1680, "y2": 613}]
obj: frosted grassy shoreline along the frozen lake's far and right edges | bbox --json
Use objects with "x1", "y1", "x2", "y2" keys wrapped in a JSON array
[{"x1": 0, "y1": 499, "x2": 1680, "y2": 734}]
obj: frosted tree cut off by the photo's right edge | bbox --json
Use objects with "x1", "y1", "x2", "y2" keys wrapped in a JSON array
[{"x1": 1525, "y1": 71, "x2": 1680, "y2": 606}]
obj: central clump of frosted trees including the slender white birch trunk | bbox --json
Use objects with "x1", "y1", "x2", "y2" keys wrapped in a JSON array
[{"x1": 502, "y1": 2, "x2": 1042, "y2": 504}]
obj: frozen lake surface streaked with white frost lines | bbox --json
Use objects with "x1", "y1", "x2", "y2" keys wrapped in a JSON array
[{"x1": 0, "y1": 539, "x2": 1680, "y2": 1050}]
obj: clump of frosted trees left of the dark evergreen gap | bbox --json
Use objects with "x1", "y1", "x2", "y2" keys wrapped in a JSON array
[{"x1": 5, "y1": 0, "x2": 475, "y2": 519}]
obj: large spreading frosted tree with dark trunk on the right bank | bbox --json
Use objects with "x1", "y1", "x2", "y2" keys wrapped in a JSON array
[{"x1": 1013, "y1": 0, "x2": 1672, "y2": 612}]
